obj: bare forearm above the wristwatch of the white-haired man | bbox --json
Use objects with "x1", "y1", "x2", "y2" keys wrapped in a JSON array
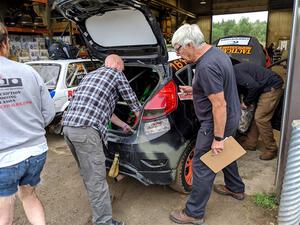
[{"x1": 212, "y1": 104, "x2": 227, "y2": 137}]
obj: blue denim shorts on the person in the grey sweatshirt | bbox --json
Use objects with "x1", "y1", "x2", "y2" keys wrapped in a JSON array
[{"x1": 0, "y1": 152, "x2": 47, "y2": 197}]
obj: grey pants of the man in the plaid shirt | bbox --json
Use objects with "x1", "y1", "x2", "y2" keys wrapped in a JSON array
[{"x1": 63, "y1": 127, "x2": 112, "y2": 225}]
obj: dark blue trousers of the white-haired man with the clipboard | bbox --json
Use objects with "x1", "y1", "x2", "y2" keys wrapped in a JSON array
[{"x1": 185, "y1": 127, "x2": 245, "y2": 218}]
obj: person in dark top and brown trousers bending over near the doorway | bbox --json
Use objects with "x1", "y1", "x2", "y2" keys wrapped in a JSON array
[{"x1": 234, "y1": 63, "x2": 283, "y2": 160}]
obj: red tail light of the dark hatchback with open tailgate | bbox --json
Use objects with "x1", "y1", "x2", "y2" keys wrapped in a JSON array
[{"x1": 142, "y1": 80, "x2": 177, "y2": 121}]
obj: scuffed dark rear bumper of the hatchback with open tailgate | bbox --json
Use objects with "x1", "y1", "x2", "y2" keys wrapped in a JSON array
[{"x1": 105, "y1": 132, "x2": 184, "y2": 185}]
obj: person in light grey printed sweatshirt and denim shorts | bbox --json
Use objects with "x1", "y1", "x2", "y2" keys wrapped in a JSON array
[{"x1": 0, "y1": 23, "x2": 55, "y2": 225}]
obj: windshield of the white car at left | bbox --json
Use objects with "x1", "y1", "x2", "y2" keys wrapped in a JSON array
[{"x1": 29, "y1": 63, "x2": 60, "y2": 89}]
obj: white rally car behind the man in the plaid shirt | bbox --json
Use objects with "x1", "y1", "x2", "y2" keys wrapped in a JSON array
[{"x1": 26, "y1": 59, "x2": 101, "y2": 133}]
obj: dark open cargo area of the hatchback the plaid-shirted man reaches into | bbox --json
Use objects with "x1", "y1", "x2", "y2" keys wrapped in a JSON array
[{"x1": 108, "y1": 66, "x2": 160, "y2": 131}]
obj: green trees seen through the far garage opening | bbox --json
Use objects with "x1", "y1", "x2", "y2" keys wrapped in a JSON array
[{"x1": 212, "y1": 17, "x2": 267, "y2": 45}]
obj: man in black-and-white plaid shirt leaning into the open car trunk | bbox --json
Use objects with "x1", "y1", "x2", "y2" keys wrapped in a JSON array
[{"x1": 63, "y1": 55, "x2": 141, "y2": 225}]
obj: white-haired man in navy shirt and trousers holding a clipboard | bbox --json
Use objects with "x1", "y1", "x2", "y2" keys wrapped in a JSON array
[{"x1": 170, "y1": 24, "x2": 245, "y2": 225}]
